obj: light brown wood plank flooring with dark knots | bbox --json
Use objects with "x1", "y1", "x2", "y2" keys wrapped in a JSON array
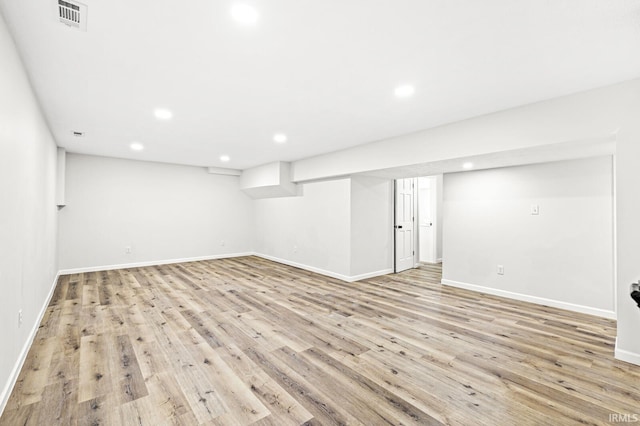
[{"x1": 0, "y1": 257, "x2": 640, "y2": 426}]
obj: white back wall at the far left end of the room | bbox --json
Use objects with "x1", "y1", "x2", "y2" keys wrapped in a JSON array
[{"x1": 59, "y1": 154, "x2": 253, "y2": 270}]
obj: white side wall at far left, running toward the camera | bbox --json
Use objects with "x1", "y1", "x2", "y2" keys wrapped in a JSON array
[{"x1": 0, "y1": 16, "x2": 57, "y2": 412}]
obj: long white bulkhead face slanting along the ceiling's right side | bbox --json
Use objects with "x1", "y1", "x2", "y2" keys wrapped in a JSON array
[{"x1": 292, "y1": 79, "x2": 640, "y2": 182}]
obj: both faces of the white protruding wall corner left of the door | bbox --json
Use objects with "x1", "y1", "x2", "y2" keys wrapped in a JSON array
[{"x1": 254, "y1": 177, "x2": 393, "y2": 281}]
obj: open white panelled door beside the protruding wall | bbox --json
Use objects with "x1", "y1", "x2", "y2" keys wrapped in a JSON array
[{"x1": 395, "y1": 178, "x2": 416, "y2": 272}]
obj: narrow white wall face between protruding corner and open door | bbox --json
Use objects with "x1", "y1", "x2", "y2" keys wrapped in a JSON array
[{"x1": 351, "y1": 176, "x2": 393, "y2": 277}]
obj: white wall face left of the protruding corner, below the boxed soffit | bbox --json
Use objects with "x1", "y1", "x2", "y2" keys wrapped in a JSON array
[{"x1": 254, "y1": 179, "x2": 351, "y2": 279}]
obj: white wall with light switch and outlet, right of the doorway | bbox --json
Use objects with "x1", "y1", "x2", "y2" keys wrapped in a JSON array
[{"x1": 443, "y1": 157, "x2": 615, "y2": 316}]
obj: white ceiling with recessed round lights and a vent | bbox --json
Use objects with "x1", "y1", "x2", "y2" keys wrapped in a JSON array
[{"x1": 0, "y1": 0, "x2": 640, "y2": 169}]
